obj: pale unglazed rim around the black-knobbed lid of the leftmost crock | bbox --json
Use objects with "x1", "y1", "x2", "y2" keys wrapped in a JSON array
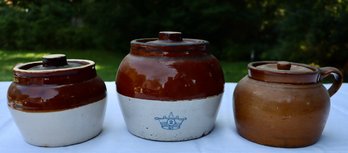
[{"x1": 13, "y1": 59, "x2": 95, "y2": 73}]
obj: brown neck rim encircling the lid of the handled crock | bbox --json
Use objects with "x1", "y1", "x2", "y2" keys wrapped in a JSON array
[{"x1": 248, "y1": 61, "x2": 320, "y2": 84}]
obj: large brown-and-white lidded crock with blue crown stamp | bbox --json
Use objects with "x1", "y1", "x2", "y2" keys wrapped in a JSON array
[{"x1": 116, "y1": 31, "x2": 224, "y2": 141}]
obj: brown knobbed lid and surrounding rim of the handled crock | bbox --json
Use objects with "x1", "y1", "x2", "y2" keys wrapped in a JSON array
[{"x1": 248, "y1": 61, "x2": 320, "y2": 84}]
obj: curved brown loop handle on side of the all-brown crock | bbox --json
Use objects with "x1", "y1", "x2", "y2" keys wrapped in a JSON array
[{"x1": 319, "y1": 67, "x2": 343, "y2": 97}]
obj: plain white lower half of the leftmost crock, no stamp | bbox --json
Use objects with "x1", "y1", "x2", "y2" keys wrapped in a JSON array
[{"x1": 10, "y1": 98, "x2": 106, "y2": 147}]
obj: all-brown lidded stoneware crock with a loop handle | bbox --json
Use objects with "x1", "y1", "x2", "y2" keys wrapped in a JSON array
[{"x1": 233, "y1": 61, "x2": 343, "y2": 147}]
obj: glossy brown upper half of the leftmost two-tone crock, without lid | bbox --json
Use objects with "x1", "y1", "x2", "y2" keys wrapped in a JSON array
[{"x1": 8, "y1": 57, "x2": 106, "y2": 112}]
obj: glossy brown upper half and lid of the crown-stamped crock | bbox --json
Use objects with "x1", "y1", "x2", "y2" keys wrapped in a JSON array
[{"x1": 116, "y1": 32, "x2": 224, "y2": 101}]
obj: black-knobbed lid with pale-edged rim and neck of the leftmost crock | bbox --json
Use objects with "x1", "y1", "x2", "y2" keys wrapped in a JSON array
[{"x1": 13, "y1": 54, "x2": 96, "y2": 84}]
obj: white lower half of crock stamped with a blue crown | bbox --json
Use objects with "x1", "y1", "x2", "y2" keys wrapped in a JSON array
[{"x1": 118, "y1": 94, "x2": 222, "y2": 141}]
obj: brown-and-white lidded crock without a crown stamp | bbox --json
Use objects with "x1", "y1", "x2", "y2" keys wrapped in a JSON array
[{"x1": 8, "y1": 54, "x2": 106, "y2": 147}]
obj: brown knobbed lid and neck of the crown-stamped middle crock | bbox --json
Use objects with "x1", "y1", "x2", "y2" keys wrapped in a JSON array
[{"x1": 131, "y1": 31, "x2": 209, "y2": 56}]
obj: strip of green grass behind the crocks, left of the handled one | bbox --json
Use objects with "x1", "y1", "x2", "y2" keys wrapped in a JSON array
[{"x1": 0, "y1": 50, "x2": 247, "y2": 82}]
